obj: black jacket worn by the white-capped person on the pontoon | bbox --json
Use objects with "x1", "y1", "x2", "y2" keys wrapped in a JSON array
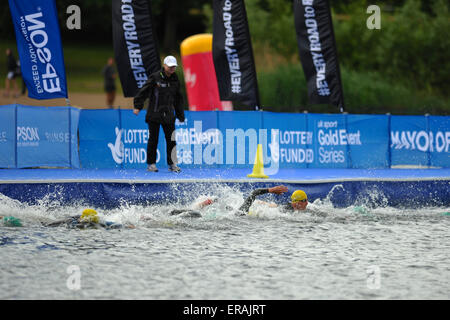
[{"x1": 134, "y1": 69, "x2": 184, "y2": 123}]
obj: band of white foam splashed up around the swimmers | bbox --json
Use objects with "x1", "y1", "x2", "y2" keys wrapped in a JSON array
[{"x1": 0, "y1": 184, "x2": 450, "y2": 227}]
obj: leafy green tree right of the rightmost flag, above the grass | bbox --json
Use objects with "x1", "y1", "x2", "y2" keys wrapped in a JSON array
[{"x1": 334, "y1": 0, "x2": 450, "y2": 95}]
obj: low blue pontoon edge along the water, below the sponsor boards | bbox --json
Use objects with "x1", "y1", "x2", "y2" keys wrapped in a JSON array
[{"x1": 0, "y1": 168, "x2": 450, "y2": 208}]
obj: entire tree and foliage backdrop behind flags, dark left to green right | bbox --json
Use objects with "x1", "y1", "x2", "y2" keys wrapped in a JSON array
[{"x1": 0, "y1": 0, "x2": 450, "y2": 115}]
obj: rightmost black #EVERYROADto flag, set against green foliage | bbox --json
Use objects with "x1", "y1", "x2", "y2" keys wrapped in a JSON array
[{"x1": 294, "y1": 0, "x2": 344, "y2": 112}]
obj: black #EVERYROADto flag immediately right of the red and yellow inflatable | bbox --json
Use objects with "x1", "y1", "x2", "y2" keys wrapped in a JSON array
[{"x1": 213, "y1": 0, "x2": 260, "y2": 109}]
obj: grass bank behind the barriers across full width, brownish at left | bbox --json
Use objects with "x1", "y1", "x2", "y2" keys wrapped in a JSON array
[{"x1": 0, "y1": 42, "x2": 450, "y2": 115}]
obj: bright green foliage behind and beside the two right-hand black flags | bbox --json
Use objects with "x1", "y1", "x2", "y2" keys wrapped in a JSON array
[{"x1": 204, "y1": 0, "x2": 450, "y2": 114}]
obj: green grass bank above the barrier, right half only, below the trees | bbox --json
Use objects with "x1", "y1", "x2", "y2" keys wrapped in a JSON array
[{"x1": 258, "y1": 63, "x2": 450, "y2": 115}]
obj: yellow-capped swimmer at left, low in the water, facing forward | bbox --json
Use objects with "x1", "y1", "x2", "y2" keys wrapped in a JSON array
[{"x1": 45, "y1": 209, "x2": 135, "y2": 229}]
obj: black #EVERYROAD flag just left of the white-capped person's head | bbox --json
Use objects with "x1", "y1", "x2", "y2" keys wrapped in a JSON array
[{"x1": 112, "y1": 0, "x2": 161, "y2": 97}]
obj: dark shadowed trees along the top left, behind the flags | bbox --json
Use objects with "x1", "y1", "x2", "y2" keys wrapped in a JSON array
[{"x1": 0, "y1": 0, "x2": 209, "y2": 52}]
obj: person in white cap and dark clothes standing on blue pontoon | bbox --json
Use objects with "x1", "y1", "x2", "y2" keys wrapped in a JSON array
[{"x1": 133, "y1": 56, "x2": 184, "y2": 172}]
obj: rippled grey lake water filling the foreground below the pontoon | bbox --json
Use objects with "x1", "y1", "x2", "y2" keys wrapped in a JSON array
[{"x1": 0, "y1": 189, "x2": 450, "y2": 300}]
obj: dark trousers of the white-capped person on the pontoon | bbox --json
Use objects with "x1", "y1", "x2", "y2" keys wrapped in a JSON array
[{"x1": 147, "y1": 121, "x2": 177, "y2": 166}]
